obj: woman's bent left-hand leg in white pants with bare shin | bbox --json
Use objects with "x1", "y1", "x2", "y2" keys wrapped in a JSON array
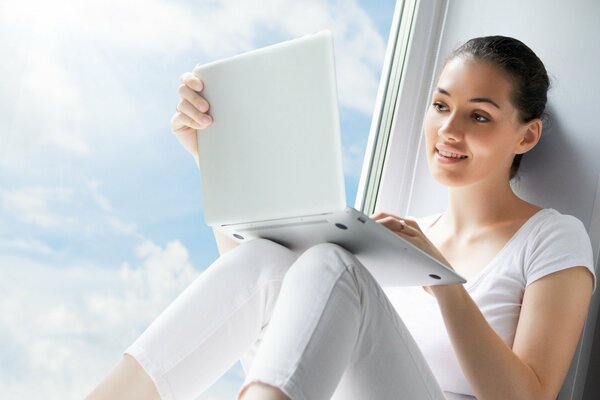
[{"x1": 88, "y1": 239, "x2": 297, "y2": 400}]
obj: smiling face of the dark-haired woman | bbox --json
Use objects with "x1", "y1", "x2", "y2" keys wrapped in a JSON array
[{"x1": 424, "y1": 57, "x2": 526, "y2": 187}]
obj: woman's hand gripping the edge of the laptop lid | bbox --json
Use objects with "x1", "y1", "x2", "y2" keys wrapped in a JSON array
[{"x1": 171, "y1": 72, "x2": 213, "y2": 164}]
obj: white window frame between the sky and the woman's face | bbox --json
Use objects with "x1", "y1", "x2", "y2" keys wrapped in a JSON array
[{"x1": 355, "y1": 0, "x2": 447, "y2": 215}]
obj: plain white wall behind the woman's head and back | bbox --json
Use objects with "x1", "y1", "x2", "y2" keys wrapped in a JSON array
[{"x1": 408, "y1": 0, "x2": 600, "y2": 399}]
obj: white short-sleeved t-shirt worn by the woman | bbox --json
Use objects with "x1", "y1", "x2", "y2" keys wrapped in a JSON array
[{"x1": 384, "y1": 209, "x2": 596, "y2": 398}]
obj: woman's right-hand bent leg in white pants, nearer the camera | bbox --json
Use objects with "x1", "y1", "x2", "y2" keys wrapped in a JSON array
[{"x1": 239, "y1": 243, "x2": 444, "y2": 400}]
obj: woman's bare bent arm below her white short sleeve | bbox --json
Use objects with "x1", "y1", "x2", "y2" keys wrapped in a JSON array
[{"x1": 430, "y1": 267, "x2": 593, "y2": 400}]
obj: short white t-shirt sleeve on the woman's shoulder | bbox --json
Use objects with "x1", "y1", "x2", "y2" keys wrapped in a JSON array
[{"x1": 525, "y1": 212, "x2": 596, "y2": 291}]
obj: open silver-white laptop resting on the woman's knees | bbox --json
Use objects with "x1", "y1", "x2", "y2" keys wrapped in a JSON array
[{"x1": 194, "y1": 31, "x2": 466, "y2": 287}]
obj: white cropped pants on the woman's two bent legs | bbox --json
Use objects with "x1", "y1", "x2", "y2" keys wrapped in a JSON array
[{"x1": 126, "y1": 239, "x2": 444, "y2": 400}]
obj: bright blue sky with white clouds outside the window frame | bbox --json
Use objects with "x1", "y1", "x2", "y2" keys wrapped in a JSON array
[{"x1": 0, "y1": 0, "x2": 394, "y2": 400}]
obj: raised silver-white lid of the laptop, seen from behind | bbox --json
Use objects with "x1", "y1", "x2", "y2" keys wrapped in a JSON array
[{"x1": 194, "y1": 31, "x2": 346, "y2": 225}]
